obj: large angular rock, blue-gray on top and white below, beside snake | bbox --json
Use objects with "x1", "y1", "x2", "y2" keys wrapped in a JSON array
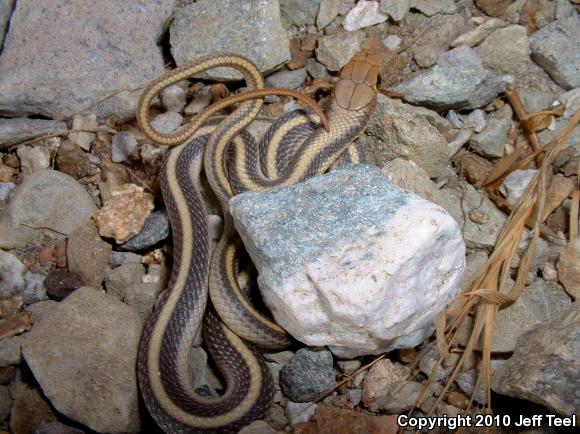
[{"x1": 230, "y1": 165, "x2": 465, "y2": 358}]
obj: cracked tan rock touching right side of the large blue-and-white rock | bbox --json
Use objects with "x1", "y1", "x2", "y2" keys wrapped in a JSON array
[{"x1": 439, "y1": 181, "x2": 506, "y2": 250}]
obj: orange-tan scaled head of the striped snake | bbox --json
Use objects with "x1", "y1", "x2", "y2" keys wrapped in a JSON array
[{"x1": 333, "y1": 50, "x2": 380, "y2": 113}]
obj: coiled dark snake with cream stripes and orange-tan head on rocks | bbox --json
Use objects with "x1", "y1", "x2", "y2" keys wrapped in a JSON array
[{"x1": 137, "y1": 51, "x2": 379, "y2": 433}]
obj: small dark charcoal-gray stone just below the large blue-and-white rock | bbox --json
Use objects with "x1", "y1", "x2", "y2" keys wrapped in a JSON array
[{"x1": 280, "y1": 348, "x2": 336, "y2": 402}]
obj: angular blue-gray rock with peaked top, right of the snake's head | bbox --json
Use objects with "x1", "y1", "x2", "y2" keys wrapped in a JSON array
[{"x1": 393, "y1": 46, "x2": 507, "y2": 110}]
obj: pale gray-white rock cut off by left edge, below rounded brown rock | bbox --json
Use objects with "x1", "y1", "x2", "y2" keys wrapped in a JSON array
[{"x1": 0, "y1": 250, "x2": 48, "y2": 304}]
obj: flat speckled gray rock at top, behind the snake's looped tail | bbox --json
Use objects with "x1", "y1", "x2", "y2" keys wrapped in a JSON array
[{"x1": 170, "y1": 0, "x2": 290, "y2": 80}]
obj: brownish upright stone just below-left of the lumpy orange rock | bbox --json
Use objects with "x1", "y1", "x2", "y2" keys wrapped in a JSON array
[{"x1": 66, "y1": 221, "x2": 112, "y2": 288}]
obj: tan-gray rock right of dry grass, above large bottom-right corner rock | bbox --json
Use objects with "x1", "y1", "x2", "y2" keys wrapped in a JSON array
[{"x1": 492, "y1": 279, "x2": 571, "y2": 352}]
